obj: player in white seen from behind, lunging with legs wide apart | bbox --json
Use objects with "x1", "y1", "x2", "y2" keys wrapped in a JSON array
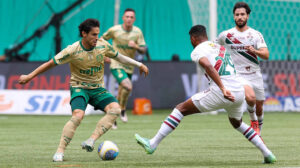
[{"x1": 135, "y1": 25, "x2": 276, "y2": 163}]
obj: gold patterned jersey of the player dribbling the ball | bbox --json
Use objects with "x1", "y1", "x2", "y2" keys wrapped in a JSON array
[{"x1": 53, "y1": 39, "x2": 118, "y2": 89}]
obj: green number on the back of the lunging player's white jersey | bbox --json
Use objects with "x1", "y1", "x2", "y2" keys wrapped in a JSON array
[{"x1": 214, "y1": 46, "x2": 235, "y2": 76}]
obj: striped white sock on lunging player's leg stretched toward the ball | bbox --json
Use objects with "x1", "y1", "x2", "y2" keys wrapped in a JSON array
[{"x1": 150, "y1": 108, "x2": 183, "y2": 148}]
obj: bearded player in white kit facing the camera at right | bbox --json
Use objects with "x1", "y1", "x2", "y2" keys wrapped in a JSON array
[{"x1": 216, "y1": 2, "x2": 269, "y2": 135}]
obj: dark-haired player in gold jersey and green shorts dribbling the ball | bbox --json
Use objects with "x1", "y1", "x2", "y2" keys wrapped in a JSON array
[{"x1": 19, "y1": 19, "x2": 148, "y2": 162}]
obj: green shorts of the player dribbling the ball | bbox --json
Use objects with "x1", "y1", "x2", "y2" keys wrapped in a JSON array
[{"x1": 70, "y1": 87, "x2": 118, "y2": 111}]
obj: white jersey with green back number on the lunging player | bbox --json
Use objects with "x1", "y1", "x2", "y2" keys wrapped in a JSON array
[{"x1": 191, "y1": 41, "x2": 243, "y2": 91}]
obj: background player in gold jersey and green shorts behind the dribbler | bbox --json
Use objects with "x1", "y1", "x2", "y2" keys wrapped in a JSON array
[{"x1": 102, "y1": 8, "x2": 146, "y2": 128}]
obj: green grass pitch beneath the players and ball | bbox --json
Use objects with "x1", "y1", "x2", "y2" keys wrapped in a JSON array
[{"x1": 0, "y1": 110, "x2": 300, "y2": 168}]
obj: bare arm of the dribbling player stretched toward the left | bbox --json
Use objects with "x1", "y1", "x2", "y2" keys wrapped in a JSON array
[{"x1": 19, "y1": 59, "x2": 55, "y2": 84}]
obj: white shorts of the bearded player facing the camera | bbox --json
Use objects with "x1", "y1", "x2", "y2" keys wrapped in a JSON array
[{"x1": 238, "y1": 71, "x2": 265, "y2": 100}]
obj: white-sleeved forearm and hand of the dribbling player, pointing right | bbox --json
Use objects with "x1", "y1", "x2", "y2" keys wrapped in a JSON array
[{"x1": 114, "y1": 53, "x2": 149, "y2": 76}]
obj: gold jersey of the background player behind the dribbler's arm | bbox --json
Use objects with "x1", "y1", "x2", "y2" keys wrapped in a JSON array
[{"x1": 102, "y1": 25, "x2": 145, "y2": 74}]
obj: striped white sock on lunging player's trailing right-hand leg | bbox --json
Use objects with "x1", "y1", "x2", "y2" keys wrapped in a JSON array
[{"x1": 237, "y1": 122, "x2": 272, "y2": 157}]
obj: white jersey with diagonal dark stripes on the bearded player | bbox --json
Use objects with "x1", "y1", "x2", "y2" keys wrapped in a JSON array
[{"x1": 216, "y1": 27, "x2": 267, "y2": 73}]
